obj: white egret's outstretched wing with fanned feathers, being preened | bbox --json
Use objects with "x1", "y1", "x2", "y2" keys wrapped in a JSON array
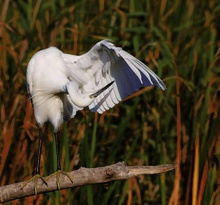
[{"x1": 63, "y1": 40, "x2": 166, "y2": 113}]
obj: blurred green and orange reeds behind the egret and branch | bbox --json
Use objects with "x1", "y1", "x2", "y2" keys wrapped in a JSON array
[{"x1": 0, "y1": 0, "x2": 220, "y2": 205}]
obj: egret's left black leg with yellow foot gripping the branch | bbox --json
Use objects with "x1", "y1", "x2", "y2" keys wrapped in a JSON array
[{"x1": 21, "y1": 128, "x2": 47, "y2": 195}]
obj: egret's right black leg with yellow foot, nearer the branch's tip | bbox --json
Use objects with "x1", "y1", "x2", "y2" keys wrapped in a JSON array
[{"x1": 46, "y1": 132, "x2": 73, "y2": 189}]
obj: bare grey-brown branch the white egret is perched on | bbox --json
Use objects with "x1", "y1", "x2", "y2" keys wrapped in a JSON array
[{"x1": 0, "y1": 162, "x2": 176, "y2": 202}]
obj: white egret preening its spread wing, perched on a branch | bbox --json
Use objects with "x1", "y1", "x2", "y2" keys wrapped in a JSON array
[{"x1": 22, "y1": 40, "x2": 166, "y2": 194}]
